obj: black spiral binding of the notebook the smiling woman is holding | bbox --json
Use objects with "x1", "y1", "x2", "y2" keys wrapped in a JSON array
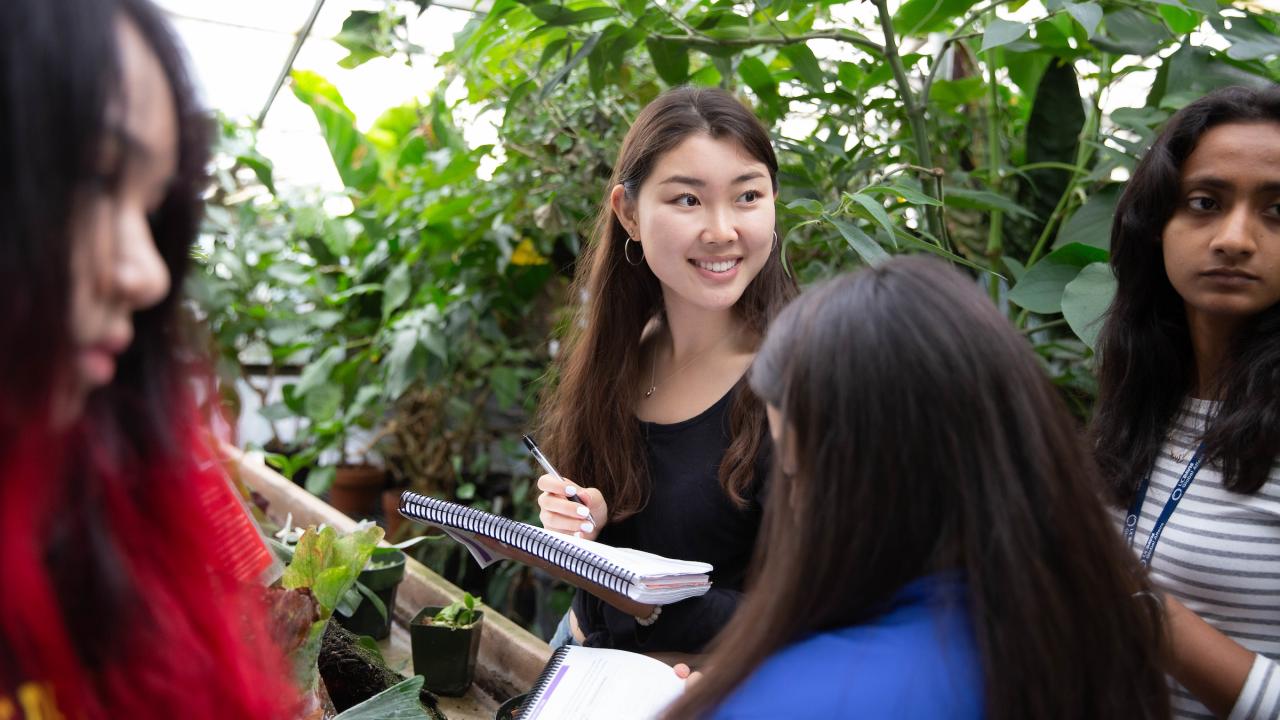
[{"x1": 399, "y1": 491, "x2": 639, "y2": 597}]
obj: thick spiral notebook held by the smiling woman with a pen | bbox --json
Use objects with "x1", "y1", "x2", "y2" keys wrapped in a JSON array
[{"x1": 399, "y1": 492, "x2": 712, "y2": 605}]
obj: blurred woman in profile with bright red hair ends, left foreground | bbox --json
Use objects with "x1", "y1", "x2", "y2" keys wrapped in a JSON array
[{"x1": 0, "y1": 0, "x2": 296, "y2": 720}]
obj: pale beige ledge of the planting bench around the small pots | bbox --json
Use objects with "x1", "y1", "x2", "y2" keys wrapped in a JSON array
[{"x1": 224, "y1": 447, "x2": 552, "y2": 702}]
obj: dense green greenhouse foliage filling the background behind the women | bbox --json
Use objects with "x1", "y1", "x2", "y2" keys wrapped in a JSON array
[{"x1": 192, "y1": 0, "x2": 1280, "y2": 630}]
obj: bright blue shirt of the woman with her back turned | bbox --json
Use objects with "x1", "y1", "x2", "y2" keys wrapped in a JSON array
[{"x1": 712, "y1": 574, "x2": 984, "y2": 720}]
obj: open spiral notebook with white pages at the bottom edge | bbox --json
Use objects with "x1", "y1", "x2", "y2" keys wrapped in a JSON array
[{"x1": 517, "y1": 646, "x2": 685, "y2": 720}]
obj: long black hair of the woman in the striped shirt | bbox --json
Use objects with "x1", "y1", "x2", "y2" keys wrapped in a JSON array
[{"x1": 1091, "y1": 86, "x2": 1280, "y2": 505}]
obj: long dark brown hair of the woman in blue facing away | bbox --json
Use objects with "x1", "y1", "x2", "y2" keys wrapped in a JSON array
[{"x1": 671, "y1": 258, "x2": 1169, "y2": 720}]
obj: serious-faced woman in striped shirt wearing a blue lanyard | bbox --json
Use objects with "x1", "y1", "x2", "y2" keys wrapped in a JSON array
[{"x1": 1093, "y1": 86, "x2": 1280, "y2": 719}]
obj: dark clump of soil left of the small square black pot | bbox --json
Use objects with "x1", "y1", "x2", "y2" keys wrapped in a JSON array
[{"x1": 319, "y1": 623, "x2": 444, "y2": 720}]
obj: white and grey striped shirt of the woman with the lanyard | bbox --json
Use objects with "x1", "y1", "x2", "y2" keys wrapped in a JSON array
[{"x1": 1134, "y1": 398, "x2": 1280, "y2": 720}]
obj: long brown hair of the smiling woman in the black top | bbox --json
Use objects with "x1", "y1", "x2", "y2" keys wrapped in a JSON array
[{"x1": 538, "y1": 87, "x2": 797, "y2": 520}]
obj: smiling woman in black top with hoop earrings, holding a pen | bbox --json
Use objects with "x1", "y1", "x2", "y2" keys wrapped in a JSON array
[{"x1": 527, "y1": 87, "x2": 796, "y2": 652}]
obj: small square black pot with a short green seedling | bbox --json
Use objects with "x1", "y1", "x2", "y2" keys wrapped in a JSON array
[{"x1": 408, "y1": 593, "x2": 484, "y2": 697}]
